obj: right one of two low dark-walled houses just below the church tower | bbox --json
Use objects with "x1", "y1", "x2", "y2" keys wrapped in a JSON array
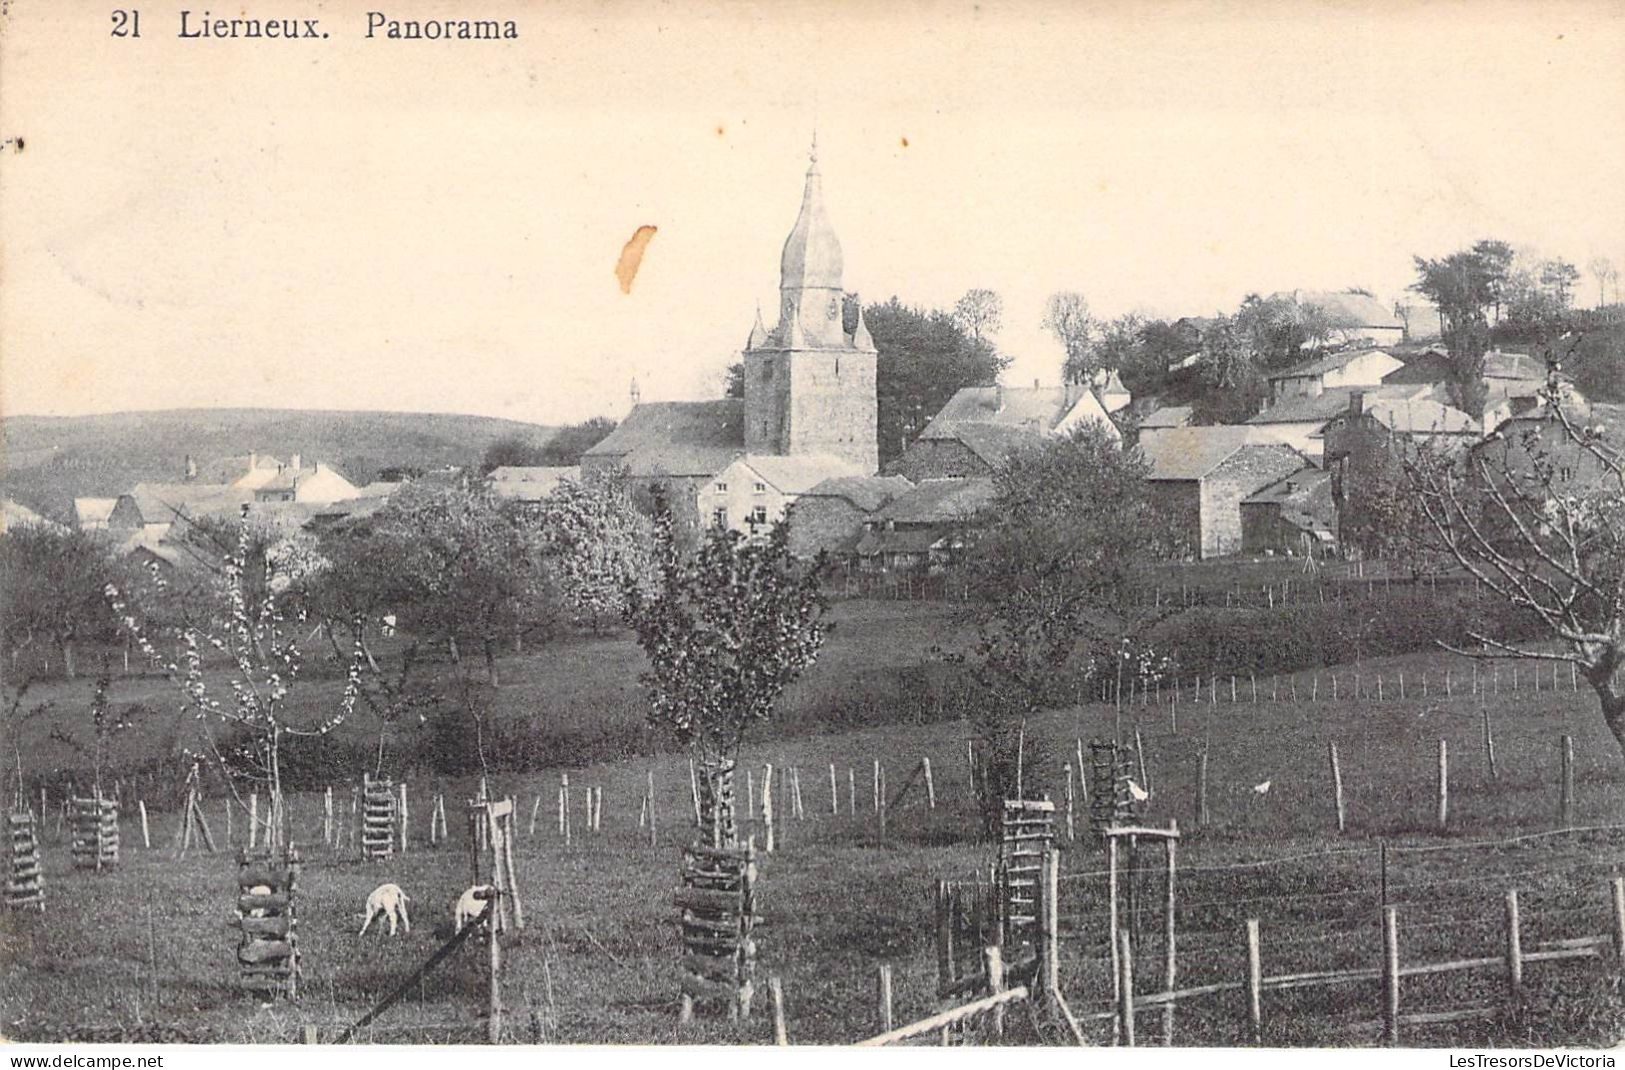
[{"x1": 856, "y1": 478, "x2": 993, "y2": 572}]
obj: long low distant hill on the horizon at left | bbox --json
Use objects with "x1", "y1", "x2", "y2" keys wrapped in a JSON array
[{"x1": 0, "y1": 408, "x2": 556, "y2": 519}]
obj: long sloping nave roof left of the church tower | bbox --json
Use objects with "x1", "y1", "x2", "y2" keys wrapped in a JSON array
[{"x1": 585, "y1": 398, "x2": 744, "y2": 476}]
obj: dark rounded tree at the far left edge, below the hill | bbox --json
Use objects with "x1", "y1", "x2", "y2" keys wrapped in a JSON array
[{"x1": 0, "y1": 524, "x2": 119, "y2": 680}]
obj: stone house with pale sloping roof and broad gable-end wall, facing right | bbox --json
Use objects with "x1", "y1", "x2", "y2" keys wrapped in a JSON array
[{"x1": 1141, "y1": 426, "x2": 1307, "y2": 559}]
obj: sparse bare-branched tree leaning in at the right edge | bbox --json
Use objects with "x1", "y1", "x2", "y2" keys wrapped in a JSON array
[{"x1": 1407, "y1": 340, "x2": 1625, "y2": 748}]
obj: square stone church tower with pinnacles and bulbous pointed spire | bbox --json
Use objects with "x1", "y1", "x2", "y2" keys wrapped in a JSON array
[{"x1": 744, "y1": 140, "x2": 879, "y2": 473}]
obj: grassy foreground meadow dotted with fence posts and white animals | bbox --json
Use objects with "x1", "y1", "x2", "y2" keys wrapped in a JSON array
[{"x1": 0, "y1": 634, "x2": 1625, "y2": 1044}]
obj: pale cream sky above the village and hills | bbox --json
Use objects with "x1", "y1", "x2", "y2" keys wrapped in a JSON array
[{"x1": 0, "y1": 0, "x2": 1625, "y2": 423}]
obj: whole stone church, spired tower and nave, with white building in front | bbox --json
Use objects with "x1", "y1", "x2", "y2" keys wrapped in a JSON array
[{"x1": 582, "y1": 147, "x2": 879, "y2": 528}]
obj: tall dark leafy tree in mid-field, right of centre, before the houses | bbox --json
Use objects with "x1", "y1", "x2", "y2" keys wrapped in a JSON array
[{"x1": 964, "y1": 424, "x2": 1167, "y2": 829}]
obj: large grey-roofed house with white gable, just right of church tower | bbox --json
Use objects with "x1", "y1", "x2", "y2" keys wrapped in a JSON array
[{"x1": 887, "y1": 376, "x2": 1126, "y2": 483}]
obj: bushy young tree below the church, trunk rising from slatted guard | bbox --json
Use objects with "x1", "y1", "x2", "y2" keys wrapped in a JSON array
[{"x1": 626, "y1": 501, "x2": 827, "y2": 846}]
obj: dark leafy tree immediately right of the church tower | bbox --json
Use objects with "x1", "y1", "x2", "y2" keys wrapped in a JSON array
[{"x1": 863, "y1": 298, "x2": 1009, "y2": 467}]
